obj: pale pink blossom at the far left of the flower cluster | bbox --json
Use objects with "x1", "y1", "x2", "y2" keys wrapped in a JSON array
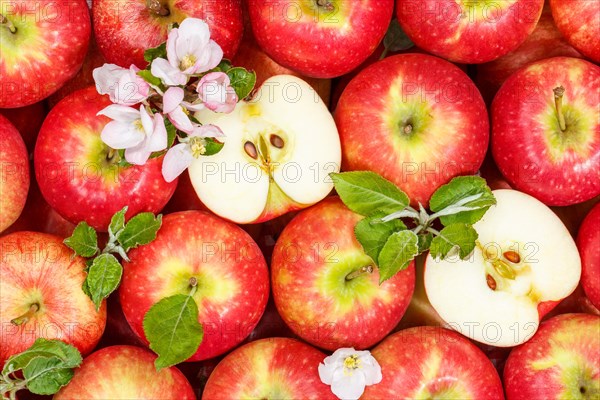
[{"x1": 92, "y1": 64, "x2": 150, "y2": 106}]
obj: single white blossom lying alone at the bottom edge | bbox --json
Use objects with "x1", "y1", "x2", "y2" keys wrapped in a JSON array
[{"x1": 319, "y1": 348, "x2": 382, "y2": 400}]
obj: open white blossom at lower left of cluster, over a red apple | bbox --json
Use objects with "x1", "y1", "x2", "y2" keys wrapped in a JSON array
[{"x1": 97, "y1": 104, "x2": 167, "y2": 165}]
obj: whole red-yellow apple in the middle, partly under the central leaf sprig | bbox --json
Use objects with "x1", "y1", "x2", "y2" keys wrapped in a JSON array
[{"x1": 271, "y1": 197, "x2": 415, "y2": 350}]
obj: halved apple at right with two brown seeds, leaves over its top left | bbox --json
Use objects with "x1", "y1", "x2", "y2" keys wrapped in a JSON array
[{"x1": 425, "y1": 189, "x2": 581, "y2": 347}]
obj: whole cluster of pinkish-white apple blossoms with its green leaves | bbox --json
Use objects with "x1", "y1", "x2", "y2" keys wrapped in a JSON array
[{"x1": 93, "y1": 18, "x2": 256, "y2": 182}]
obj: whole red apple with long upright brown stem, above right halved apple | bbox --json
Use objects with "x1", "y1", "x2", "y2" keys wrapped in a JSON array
[{"x1": 492, "y1": 57, "x2": 600, "y2": 206}]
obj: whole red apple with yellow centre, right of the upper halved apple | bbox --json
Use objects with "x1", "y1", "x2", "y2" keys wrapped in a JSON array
[{"x1": 335, "y1": 54, "x2": 489, "y2": 206}]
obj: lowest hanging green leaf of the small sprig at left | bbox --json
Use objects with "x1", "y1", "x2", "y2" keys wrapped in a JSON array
[{"x1": 86, "y1": 253, "x2": 123, "y2": 310}]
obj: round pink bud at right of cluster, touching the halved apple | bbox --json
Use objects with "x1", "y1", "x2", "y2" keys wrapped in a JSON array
[{"x1": 196, "y1": 72, "x2": 238, "y2": 113}]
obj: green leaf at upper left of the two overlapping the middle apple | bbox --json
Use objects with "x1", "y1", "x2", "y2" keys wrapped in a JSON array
[{"x1": 354, "y1": 212, "x2": 406, "y2": 264}]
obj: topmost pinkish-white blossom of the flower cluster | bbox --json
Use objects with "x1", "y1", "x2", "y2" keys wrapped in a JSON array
[{"x1": 150, "y1": 18, "x2": 223, "y2": 86}]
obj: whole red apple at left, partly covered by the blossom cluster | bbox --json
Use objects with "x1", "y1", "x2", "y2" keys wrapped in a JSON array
[{"x1": 34, "y1": 86, "x2": 177, "y2": 232}]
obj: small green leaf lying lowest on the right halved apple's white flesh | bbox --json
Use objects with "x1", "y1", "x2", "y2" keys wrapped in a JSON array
[{"x1": 429, "y1": 224, "x2": 478, "y2": 260}]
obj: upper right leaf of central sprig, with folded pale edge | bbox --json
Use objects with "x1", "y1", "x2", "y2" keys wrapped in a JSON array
[{"x1": 429, "y1": 176, "x2": 496, "y2": 226}]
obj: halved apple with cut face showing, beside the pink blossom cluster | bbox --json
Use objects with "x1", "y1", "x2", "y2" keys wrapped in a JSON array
[{"x1": 189, "y1": 75, "x2": 341, "y2": 223}]
